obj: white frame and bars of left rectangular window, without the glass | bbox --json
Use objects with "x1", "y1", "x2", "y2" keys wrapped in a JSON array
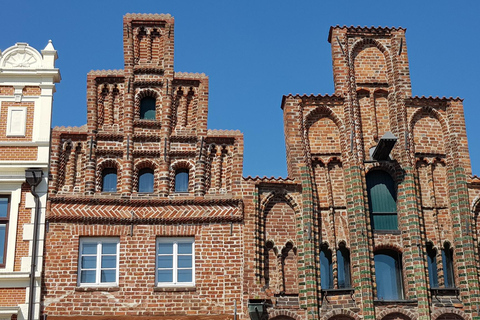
[{"x1": 77, "y1": 237, "x2": 120, "y2": 287}]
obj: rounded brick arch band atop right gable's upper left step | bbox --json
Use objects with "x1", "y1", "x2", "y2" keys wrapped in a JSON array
[{"x1": 304, "y1": 105, "x2": 347, "y2": 154}]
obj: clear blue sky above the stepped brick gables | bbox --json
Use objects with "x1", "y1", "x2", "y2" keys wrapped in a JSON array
[{"x1": 0, "y1": 0, "x2": 480, "y2": 177}]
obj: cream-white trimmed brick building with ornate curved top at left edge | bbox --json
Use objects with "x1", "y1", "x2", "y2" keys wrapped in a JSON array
[{"x1": 0, "y1": 42, "x2": 60, "y2": 320}]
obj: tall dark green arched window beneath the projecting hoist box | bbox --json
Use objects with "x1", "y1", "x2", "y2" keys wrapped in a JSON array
[{"x1": 366, "y1": 170, "x2": 398, "y2": 230}]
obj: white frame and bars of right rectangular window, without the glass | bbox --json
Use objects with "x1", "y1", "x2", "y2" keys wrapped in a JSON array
[{"x1": 155, "y1": 237, "x2": 195, "y2": 287}]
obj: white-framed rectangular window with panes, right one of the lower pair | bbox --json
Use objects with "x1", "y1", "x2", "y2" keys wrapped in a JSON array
[{"x1": 155, "y1": 238, "x2": 195, "y2": 287}]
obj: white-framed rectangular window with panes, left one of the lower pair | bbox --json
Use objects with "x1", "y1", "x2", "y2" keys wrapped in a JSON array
[{"x1": 78, "y1": 238, "x2": 120, "y2": 286}]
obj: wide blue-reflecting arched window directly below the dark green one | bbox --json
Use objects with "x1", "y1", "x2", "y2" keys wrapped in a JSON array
[{"x1": 375, "y1": 250, "x2": 403, "y2": 300}]
